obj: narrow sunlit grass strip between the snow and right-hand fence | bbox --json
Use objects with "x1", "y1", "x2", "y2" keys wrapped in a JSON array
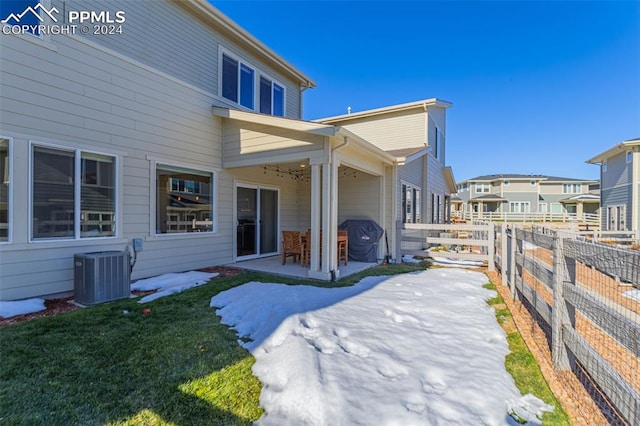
[{"x1": 484, "y1": 283, "x2": 571, "y2": 426}]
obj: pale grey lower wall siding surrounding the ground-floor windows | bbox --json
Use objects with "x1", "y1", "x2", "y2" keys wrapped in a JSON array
[{"x1": 0, "y1": 31, "x2": 238, "y2": 300}]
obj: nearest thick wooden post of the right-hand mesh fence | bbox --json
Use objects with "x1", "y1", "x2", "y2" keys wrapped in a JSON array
[{"x1": 551, "y1": 231, "x2": 576, "y2": 370}]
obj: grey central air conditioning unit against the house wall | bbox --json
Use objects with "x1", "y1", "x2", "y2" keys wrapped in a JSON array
[{"x1": 73, "y1": 251, "x2": 131, "y2": 305}]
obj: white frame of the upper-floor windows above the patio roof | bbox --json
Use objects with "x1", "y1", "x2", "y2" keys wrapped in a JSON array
[{"x1": 218, "y1": 46, "x2": 287, "y2": 117}]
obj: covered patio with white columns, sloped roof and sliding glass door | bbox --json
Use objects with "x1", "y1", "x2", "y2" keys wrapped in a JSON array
[{"x1": 213, "y1": 107, "x2": 397, "y2": 281}]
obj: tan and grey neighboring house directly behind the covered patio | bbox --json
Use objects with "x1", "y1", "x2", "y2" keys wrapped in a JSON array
[{"x1": 315, "y1": 99, "x2": 456, "y2": 223}]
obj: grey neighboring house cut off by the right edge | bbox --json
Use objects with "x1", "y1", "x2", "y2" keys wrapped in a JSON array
[{"x1": 587, "y1": 138, "x2": 640, "y2": 233}]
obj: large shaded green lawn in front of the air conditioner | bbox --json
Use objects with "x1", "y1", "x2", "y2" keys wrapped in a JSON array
[{"x1": 0, "y1": 264, "x2": 568, "y2": 425}]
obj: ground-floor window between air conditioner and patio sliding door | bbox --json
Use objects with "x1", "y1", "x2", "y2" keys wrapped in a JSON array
[{"x1": 156, "y1": 164, "x2": 213, "y2": 234}]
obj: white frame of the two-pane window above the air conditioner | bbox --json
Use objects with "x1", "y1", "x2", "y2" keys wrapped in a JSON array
[{"x1": 28, "y1": 140, "x2": 122, "y2": 244}]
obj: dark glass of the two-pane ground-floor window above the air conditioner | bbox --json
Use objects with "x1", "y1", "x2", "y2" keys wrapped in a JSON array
[{"x1": 31, "y1": 146, "x2": 116, "y2": 240}]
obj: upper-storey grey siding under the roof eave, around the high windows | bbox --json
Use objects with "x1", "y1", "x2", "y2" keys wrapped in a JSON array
[{"x1": 52, "y1": 0, "x2": 301, "y2": 118}]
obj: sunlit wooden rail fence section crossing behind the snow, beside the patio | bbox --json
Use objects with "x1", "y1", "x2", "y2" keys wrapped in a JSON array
[{"x1": 397, "y1": 222, "x2": 495, "y2": 270}]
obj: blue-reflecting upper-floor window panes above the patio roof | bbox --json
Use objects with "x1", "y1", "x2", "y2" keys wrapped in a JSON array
[{"x1": 220, "y1": 52, "x2": 286, "y2": 117}]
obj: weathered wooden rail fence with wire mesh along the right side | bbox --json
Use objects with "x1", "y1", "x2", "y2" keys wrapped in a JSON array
[{"x1": 495, "y1": 224, "x2": 640, "y2": 425}]
